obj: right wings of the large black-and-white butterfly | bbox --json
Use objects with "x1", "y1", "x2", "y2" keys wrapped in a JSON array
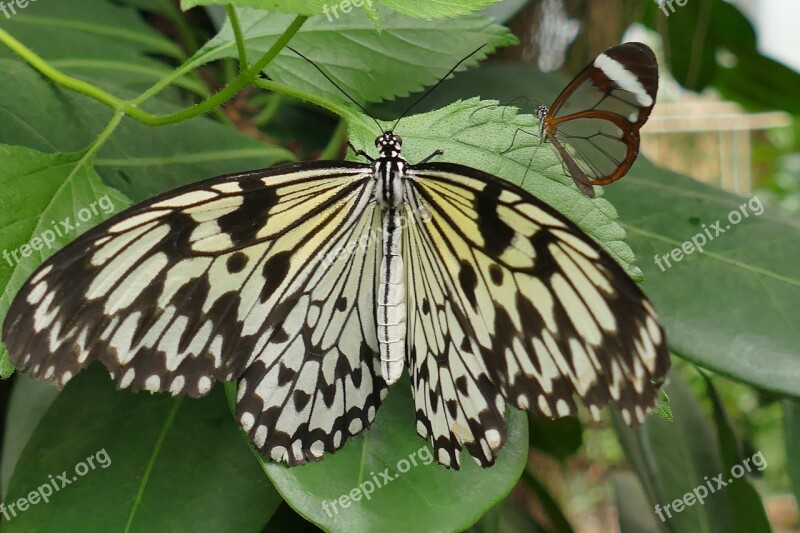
[{"x1": 407, "y1": 163, "x2": 669, "y2": 467}]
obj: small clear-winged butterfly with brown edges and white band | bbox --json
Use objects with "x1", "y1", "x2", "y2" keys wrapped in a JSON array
[{"x1": 536, "y1": 42, "x2": 658, "y2": 197}]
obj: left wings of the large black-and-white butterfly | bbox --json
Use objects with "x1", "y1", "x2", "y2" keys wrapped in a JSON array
[{"x1": 3, "y1": 162, "x2": 386, "y2": 464}]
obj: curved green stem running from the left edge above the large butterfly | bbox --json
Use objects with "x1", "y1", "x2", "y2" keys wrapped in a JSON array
[{"x1": 0, "y1": 15, "x2": 308, "y2": 126}]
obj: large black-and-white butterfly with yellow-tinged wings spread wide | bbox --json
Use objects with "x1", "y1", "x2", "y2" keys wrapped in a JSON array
[{"x1": 3, "y1": 122, "x2": 669, "y2": 468}]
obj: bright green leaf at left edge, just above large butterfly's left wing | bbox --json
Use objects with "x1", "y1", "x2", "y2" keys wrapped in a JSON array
[{"x1": 0, "y1": 145, "x2": 130, "y2": 377}]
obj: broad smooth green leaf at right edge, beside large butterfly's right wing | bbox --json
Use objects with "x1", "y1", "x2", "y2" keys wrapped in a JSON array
[{"x1": 606, "y1": 161, "x2": 800, "y2": 395}]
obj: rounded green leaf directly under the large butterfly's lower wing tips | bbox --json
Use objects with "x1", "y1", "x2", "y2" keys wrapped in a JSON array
[{"x1": 247, "y1": 378, "x2": 528, "y2": 533}]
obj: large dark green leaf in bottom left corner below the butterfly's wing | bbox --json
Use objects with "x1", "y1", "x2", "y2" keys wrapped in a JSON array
[{"x1": 3, "y1": 364, "x2": 281, "y2": 533}]
